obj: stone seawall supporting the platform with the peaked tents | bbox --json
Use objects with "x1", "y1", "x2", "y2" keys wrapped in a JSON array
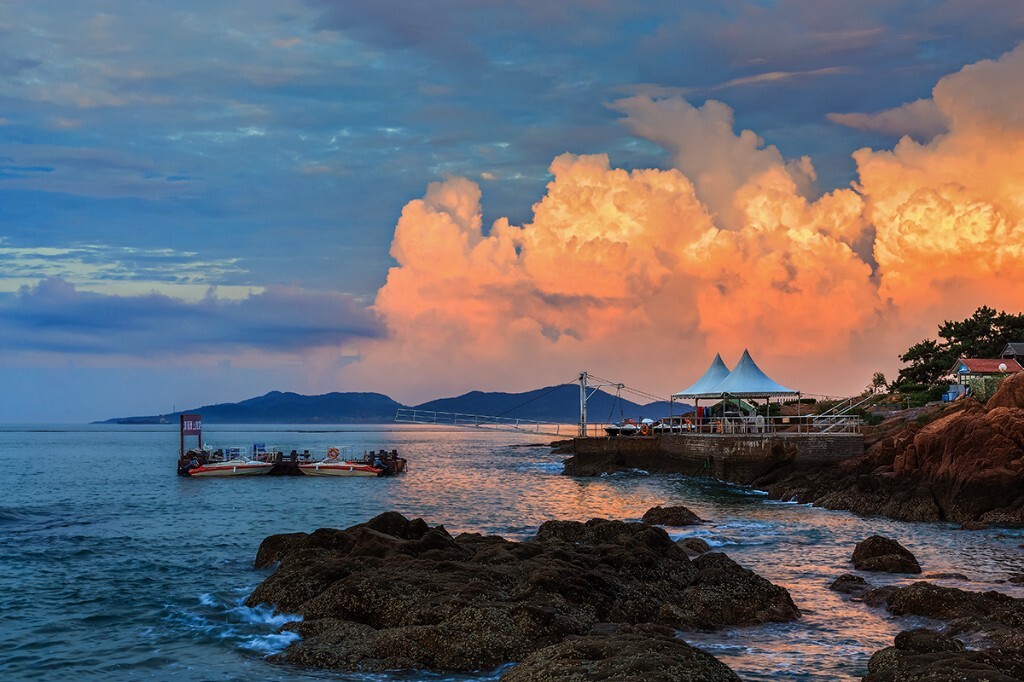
[{"x1": 565, "y1": 433, "x2": 864, "y2": 485}]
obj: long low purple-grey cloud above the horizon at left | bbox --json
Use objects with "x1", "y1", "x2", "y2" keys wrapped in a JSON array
[{"x1": 0, "y1": 278, "x2": 384, "y2": 357}]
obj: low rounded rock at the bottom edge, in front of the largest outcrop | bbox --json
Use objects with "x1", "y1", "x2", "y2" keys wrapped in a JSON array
[{"x1": 501, "y1": 629, "x2": 740, "y2": 682}]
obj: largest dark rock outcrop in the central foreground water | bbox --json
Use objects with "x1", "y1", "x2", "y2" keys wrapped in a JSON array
[{"x1": 247, "y1": 512, "x2": 800, "y2": 679}]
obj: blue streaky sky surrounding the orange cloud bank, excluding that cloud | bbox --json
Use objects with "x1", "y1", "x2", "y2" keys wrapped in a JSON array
[{"x1": 0, "y1": 0, "x2": 1024, "y2": 422}]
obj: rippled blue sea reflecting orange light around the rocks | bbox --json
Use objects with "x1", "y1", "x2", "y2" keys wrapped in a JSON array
[{"x1": 0, "y1": 425, "x2": 1024, "y2": 681}]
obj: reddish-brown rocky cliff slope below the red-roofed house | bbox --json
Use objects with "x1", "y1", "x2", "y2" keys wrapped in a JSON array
[{"x1": 754, "y1": 374, "x2": 1024, "y2": 525}]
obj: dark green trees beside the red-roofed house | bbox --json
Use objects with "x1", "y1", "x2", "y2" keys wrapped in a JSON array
[{"x1": 893, "y1": 305, "x2": 1024, "y2": 387}]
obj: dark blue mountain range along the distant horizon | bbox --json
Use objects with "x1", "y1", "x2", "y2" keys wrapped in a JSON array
[{"x1": 98, "y1": 384, "x2": 686, "y2": 424}]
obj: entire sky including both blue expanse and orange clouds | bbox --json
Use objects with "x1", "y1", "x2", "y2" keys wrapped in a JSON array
[{"x1": 0, "y1": 0, "x2": 1024, "y2": 423}]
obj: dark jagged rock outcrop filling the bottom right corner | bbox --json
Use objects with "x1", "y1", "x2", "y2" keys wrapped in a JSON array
[{"x1": 864, "y1": 583, "x2": 1024, "y2": 682}]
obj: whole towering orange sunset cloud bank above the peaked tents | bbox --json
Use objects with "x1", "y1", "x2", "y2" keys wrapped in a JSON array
[{"x1": 350, "y1": 47, "x2": 1024, "y2": 398}]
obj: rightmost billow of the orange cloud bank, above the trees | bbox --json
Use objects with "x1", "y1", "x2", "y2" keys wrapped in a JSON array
[{"x1": 854, "y1": 45, "x2": 1024, "y2": 318}]
